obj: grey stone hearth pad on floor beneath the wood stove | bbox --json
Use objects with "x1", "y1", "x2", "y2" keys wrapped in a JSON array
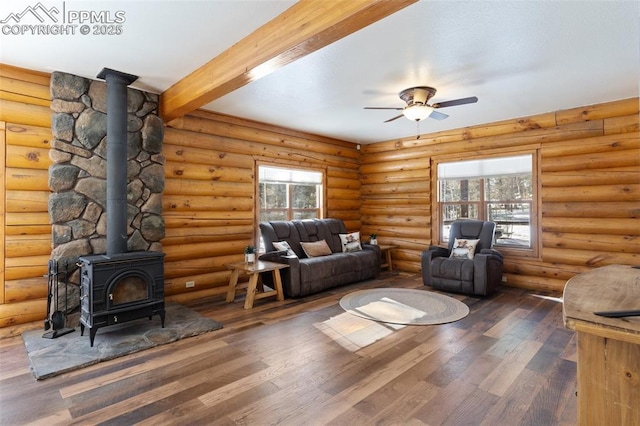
[{"x1": 22, "y1": 303, "x2": 222, "y2": 380}]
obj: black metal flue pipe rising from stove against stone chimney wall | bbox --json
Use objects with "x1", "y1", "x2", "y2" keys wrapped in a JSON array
[{"x1": 97, "y1": 68, "x2": 138, "y2": 256}]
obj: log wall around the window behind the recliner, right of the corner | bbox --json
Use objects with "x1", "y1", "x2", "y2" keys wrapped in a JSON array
[{"x1": 360, "y1": 98, "x2": 640, "y2": 291}]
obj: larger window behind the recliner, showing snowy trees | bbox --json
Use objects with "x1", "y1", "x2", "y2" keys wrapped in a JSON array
[{"x1": 438, "y1": 154, "x2": 534, "y2": 249}]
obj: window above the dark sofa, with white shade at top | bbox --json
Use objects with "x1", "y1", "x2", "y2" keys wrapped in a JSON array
[{"x1": 258, "y1": 166, "x2": 323, "y2": 222}]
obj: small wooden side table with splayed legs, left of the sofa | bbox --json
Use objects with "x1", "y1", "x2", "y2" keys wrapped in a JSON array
[{"x1": 222, "y1": 260, "x2": 289, "y2": 309}]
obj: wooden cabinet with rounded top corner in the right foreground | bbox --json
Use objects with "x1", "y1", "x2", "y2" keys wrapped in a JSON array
[{"x1": 564, "y1": 265, "x2": 640, "y2": 425}]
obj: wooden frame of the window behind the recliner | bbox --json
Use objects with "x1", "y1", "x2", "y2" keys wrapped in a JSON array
[{"x1": 431, "y1": 148, "x2": 541, "y2": 259}]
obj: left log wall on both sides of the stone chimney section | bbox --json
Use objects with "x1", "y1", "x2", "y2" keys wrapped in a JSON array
[{"x1": 0, "y1": 65, "x2": 360, "y2": 327}]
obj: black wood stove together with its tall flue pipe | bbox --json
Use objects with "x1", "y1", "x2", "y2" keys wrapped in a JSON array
[{"x1": 79, "y1": 68, "x2": 165, "y2": 346}]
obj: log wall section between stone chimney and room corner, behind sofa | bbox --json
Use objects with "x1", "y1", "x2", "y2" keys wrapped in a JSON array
[{"x1": 162, "y1": 111, "x2": 360, "y2": 300}]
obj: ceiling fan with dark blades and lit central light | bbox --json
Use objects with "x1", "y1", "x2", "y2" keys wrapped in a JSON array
[{"x1": 364, "y1": 86, "x2": 478, "y2": 123}]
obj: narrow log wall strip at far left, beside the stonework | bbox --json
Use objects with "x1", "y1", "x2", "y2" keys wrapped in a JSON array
[{"x1": 0, "y1": 65, "x2": 52, "y2": 327}]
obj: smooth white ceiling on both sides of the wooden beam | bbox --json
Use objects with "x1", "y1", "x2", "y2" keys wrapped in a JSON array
[{"x1": 0, "y1": 0, "x2": 640, "y2": 144}]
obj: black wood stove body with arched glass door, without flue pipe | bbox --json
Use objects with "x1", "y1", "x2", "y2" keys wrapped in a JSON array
[{"x1": 80, "y1": 251, "x2": 165, "y2": 347}]
